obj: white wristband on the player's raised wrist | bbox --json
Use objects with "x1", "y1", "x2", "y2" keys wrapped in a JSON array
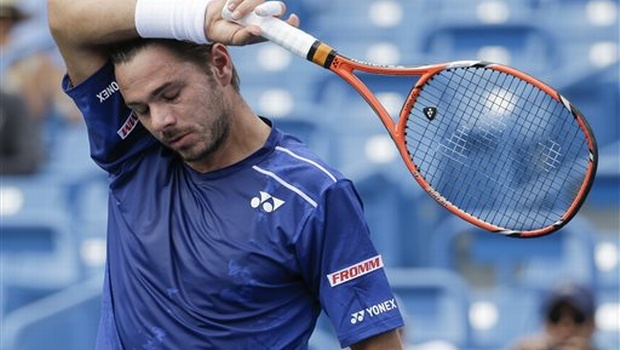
[{"x1": 135, "y1": 0, "x2": 212, "y2": 44}]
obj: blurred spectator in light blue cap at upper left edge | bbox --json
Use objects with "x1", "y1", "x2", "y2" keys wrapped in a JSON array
[{"x1": 0, "y1": 0, "x2": 83, "y2": 171}]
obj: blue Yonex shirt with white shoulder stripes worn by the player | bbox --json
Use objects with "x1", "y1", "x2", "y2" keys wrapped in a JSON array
[{"x1": 63, "y1": 64, "x2": 403, "y2": 350}]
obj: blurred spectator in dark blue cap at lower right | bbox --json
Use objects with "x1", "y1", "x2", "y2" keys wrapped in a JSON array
[{"x1": 511, "y1": 283, "x2": 596, "y2": 350}]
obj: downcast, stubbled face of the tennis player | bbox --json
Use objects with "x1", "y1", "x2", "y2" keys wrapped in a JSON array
[{"x1": 116, "y1": 44, "x2": 230, "y2": 163}]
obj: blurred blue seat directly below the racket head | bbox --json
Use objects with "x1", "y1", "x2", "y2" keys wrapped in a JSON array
[{"x1": 430, "y1": 215, "x2": 597, "y2": 290}]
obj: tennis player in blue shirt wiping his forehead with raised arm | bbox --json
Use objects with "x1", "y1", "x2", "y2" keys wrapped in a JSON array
[{"x1": 48, "y1": 0, "x2": 403, "y2": 350}]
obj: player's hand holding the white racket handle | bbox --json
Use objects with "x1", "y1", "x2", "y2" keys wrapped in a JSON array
[{"x1": 205, "y1": 0, "x2": 299, "y2": 46}]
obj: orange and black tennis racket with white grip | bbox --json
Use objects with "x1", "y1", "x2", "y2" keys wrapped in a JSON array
[{"x1": 222, "y1": 2, "x2": 598, "y2": 237}]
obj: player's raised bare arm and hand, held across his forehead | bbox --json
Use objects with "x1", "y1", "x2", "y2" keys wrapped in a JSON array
[{"x1": 48, "y1": 0, "x2": 299, "y2": 85}]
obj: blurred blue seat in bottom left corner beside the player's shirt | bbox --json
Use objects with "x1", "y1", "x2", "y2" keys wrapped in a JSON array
[{"x1": 0, "y1": 276, "x2": 102, "y2": 350}]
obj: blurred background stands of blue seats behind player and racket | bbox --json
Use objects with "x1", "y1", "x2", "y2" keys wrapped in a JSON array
[{"x1": 0, "y1": 0, "x2": 620, "y2": 350}]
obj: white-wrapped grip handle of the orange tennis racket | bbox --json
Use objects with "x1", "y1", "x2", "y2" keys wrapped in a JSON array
[{"x1": 222, "y1": 0, "x2": 317, "y2": 59}]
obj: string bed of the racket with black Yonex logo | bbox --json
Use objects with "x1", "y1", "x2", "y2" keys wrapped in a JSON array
[{"x1": 406, "y1": 67, "x2": 588, "y2": 230}]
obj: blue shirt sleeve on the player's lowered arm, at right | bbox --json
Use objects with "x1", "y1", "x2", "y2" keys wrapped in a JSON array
[{"x1": 296, "y1": 180, "x2": 404, "y2": 347}]
